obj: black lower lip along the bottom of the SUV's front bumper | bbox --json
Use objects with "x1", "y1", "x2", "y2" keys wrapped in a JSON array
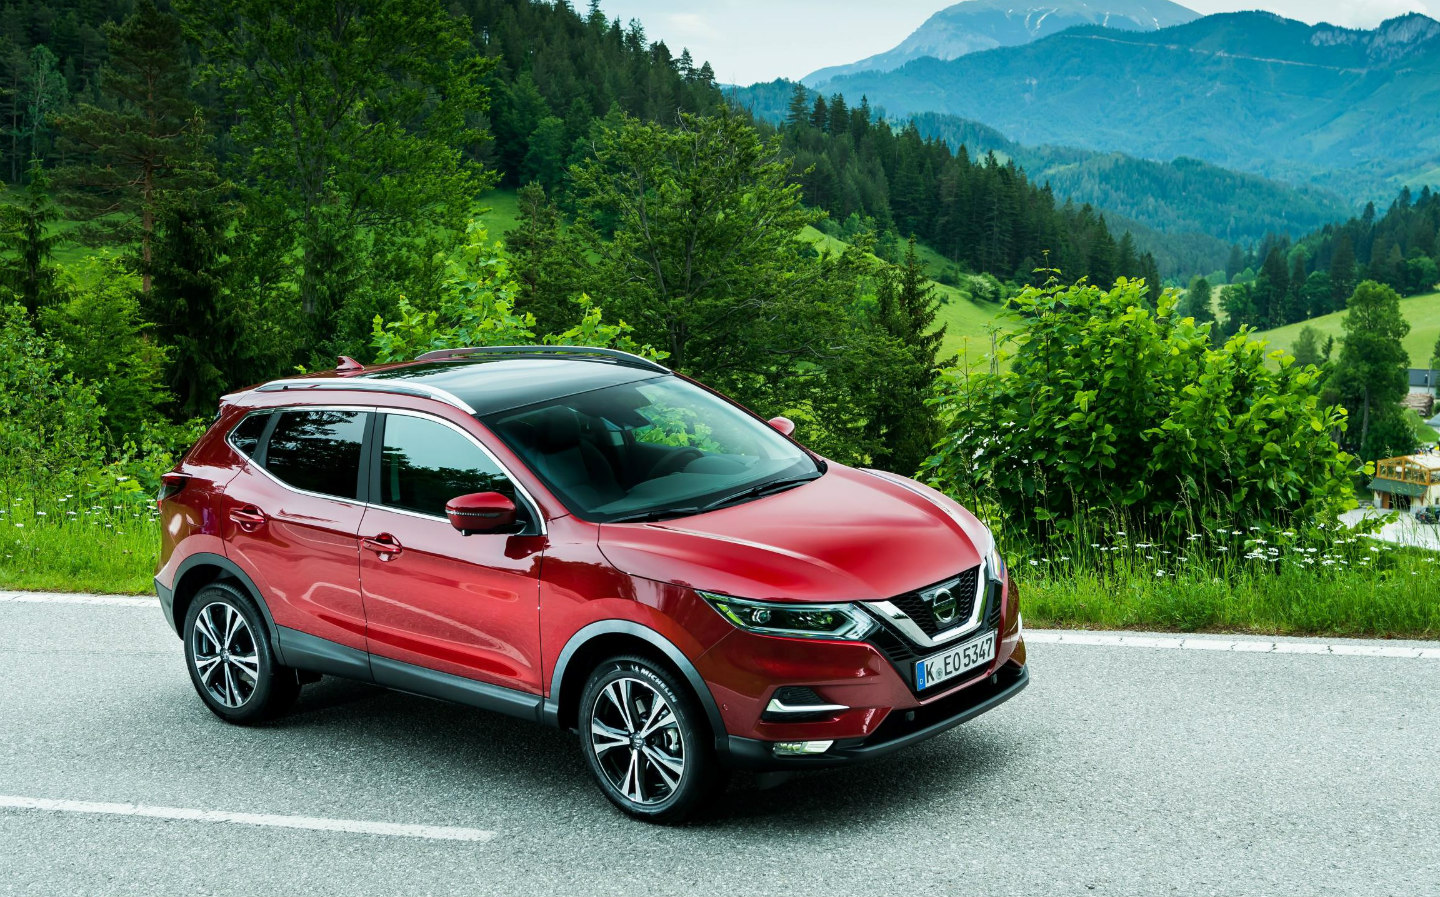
[{"x1": 717, "y1": 662, "x2": 1030, "y2": 772}]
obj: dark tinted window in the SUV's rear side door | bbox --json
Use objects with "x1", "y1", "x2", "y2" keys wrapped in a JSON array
[{"x1": 265, "y1": 410, "x2": 366, "y2": 498}]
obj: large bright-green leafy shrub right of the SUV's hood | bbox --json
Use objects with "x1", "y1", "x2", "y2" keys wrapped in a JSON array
[{"x1": 927, "y1": 278, "x2": 1355, "y2": 537}]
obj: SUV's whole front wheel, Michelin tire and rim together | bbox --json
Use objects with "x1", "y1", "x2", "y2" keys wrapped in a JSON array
[{"x1": 579, "y1": 657, "x2": 727, "y2": 824}]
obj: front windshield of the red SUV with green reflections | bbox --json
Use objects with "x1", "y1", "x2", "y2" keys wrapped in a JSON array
[{"x1": 482, "y1": 377, "x2": 821, "y2": 523}]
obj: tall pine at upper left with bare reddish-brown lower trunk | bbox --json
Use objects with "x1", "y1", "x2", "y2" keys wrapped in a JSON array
[{"x1": 55, "y1": 0, "x2": 206, "y2": 292}]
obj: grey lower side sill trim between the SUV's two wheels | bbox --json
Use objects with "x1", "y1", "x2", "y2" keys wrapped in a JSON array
[{"x1": 276, "y1": 626, "x2": 543, "y2": 721}]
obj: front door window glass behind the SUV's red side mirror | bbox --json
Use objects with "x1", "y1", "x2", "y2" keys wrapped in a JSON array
[{"x1": 380, "y1": 415, "x2": 516, "y2": 517}]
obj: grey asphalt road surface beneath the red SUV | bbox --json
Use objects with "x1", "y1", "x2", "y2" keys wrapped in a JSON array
[{"x1": 0, "y1": 600, "x2": 1440, "y2": 894}]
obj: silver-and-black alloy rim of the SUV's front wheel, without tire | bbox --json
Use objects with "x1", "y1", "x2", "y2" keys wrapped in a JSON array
[{"x1": 590, "y1": 677, "x2": 685, "y2": 806}]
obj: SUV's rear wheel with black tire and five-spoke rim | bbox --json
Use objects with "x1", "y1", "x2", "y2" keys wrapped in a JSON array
[{"x1": 181, "y1": 583, "x2": 300, "y2": 726}]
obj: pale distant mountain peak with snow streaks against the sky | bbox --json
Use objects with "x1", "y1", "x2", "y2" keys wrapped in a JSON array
[{"x1": 804, "y1": 0, "x2": 1200, "y2": 86}]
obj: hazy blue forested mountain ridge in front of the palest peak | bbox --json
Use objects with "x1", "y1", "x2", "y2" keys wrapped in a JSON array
[{"x1": 806, "y1": 13, "x2": 1440, "y2": 200}]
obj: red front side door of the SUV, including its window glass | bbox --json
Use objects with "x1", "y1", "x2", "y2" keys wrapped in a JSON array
[{"x1": 360, "y1": 412, "x2": 544, "y2": 694}]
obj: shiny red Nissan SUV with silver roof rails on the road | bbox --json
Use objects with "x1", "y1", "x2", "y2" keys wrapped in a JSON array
[{"x1": 156, "y1": 347, "x2": 1028, "y2": 821}]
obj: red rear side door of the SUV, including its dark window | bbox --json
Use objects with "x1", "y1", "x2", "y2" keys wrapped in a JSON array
[{"x1": 219, "y1": 407, "x2": 373, "y2": 651}]
